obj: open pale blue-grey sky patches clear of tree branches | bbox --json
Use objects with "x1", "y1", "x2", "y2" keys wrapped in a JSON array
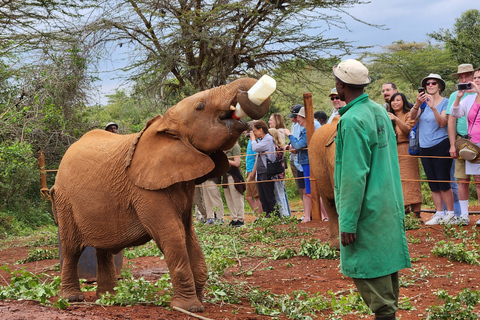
[{"x1": 89, "y1": 0, "x2": 480, "y2": 105}]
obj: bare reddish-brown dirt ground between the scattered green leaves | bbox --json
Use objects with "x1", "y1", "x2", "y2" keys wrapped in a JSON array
[{"x1": 0, "y1": 208, "x2": 480, "y2": 320}]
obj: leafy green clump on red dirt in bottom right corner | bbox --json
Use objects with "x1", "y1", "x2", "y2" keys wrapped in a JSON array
[{"x1": 427, "y1": 289, "x2": 480, "y2": 320}]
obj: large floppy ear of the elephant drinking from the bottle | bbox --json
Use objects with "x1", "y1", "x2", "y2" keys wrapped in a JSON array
[{"x1": 126, "y1": 116, "x2": 228, "y2": 190}]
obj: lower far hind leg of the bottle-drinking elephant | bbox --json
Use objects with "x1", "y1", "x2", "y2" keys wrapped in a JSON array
[{"x1": 97, "y1": 249, "x2": 117, "y2": 298}]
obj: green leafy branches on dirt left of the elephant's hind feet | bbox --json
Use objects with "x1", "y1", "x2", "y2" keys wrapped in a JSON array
[{"x1": 0, "y1": 266, "x2": 68, "y2": 309}]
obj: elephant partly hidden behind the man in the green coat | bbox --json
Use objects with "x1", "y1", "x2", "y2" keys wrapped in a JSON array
[{"x1": 308, "y1": 117, "x2": 340, "y2": 249}]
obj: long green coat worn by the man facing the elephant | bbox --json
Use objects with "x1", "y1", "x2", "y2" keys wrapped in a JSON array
[{"x1": 334, "y1": 94, "x2": 410, "y2": 279}]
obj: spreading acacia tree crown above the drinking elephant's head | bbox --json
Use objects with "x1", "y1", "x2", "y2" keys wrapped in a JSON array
[{"x1": 82, "y1": 0, "x2": 374, "y2": 95}]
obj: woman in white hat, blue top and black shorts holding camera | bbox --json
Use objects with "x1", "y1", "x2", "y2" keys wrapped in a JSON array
[{"x1": 410, "y1": 73, "x2": 456, "y2": 225}]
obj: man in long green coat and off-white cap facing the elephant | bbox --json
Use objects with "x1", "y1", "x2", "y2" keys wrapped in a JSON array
[{"x1": 333, "y1": 60, "x2": 410, "y2": 320}]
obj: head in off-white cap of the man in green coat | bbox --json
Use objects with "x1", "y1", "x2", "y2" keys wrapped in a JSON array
[{"x1": 333, "y1": 59, "x2": 371, "y2": 103}]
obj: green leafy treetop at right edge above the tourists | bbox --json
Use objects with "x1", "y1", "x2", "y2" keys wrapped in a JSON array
[{"x1": 429, "y1": 9, "x2": 480, "y2": 66}]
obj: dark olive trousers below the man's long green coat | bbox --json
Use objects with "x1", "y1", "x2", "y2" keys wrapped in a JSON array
[{"x1": 353, "y1": 272, "x2": 400, "y2": 316}]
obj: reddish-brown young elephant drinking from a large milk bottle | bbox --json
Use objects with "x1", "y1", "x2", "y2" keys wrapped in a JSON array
[{"x1": 50, "y1": 78, "x2": 270, "y2": 312}]
